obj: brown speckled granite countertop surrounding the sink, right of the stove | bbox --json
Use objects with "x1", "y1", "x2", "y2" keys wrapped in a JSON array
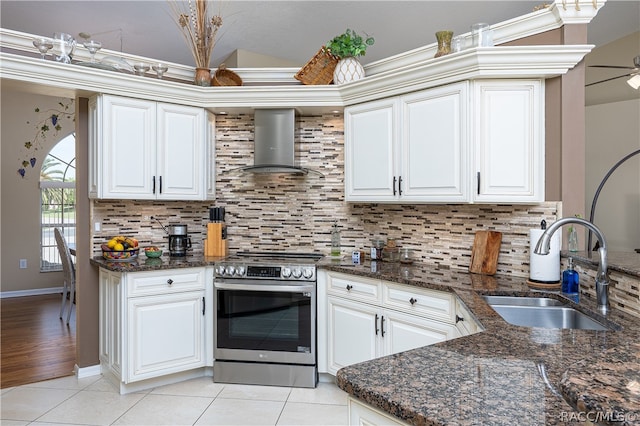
[{"x1": 320, "y1": 261, "x2": 640, "y2": 425}]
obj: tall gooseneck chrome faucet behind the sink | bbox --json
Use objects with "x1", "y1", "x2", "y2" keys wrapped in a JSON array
[{"x1": 534, "y1": 217, "x2": 609, "y2": 315}]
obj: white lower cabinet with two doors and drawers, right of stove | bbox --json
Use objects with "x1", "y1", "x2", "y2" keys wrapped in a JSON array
[{"x1": 318, "y1": 272, "x2": 461, "y2": 375}]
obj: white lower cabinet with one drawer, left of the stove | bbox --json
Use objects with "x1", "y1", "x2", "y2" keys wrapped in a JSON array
[{"x1": 100, "y1": 268, "x2": 213, "y2": 393}]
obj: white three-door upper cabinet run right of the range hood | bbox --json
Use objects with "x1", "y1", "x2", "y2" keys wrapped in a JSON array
[{"x1": 345, "y1": 79, "x2": 544, "y2": 203}]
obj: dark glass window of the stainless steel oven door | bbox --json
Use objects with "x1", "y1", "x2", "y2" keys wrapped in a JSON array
[{"x1": 216, "y1": 290, "x2": 312, "y2": 353}]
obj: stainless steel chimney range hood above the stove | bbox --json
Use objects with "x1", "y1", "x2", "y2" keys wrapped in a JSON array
[{"x1": 232, "y1": 108, "x2": 324, "y2": 177}]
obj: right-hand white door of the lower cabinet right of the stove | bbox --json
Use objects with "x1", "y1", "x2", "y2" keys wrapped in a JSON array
[{"x1": 380, "y1": 310, "x2": 460, "y2": 355}]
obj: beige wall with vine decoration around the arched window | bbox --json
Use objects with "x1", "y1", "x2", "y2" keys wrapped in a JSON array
[{"x1": 0, "y1": 88, "x2": 75, "y2": 293}]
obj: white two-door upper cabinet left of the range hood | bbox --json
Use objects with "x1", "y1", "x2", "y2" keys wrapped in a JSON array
[{"x1": 89, "y1": 95, "x2": 214, "y2": 200}]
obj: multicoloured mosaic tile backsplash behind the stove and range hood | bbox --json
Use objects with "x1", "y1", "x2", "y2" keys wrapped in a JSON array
[{"x1": 92, "y1": 114, "x2": 561, "y2": 277}]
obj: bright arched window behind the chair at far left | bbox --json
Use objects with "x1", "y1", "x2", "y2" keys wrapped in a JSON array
[{"x1": 40, "y1": 133, "x2": 76, "y2": 272}]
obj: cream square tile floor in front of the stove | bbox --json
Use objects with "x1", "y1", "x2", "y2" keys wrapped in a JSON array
[{"x1": 0, "y1": 376, "x2": 348, "y2": 426}]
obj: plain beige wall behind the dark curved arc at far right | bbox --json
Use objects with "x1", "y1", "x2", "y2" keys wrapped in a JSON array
[{"x1": 585, "y1": 98, "x2": 640, "y2": 252}]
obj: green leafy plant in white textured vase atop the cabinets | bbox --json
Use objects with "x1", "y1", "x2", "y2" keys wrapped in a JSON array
[{"x1": 326, "y1": 29, "x2": 375, "y2": 84}]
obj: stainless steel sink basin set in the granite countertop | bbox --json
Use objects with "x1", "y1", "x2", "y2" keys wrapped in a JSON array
[{"x1": 484, "y1": 296, "x2": 611, "y2": 330}]
